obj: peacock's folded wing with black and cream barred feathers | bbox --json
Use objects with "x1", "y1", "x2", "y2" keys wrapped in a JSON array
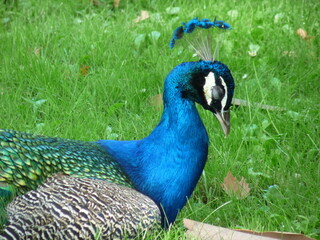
[{"x1": 0, "y1": 175, "x2": 160, "y2": 240}]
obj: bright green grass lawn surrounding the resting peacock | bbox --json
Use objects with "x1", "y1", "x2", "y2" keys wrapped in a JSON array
[{"x1": 0, "y1": 0, "x2": 320, "y2": 239}]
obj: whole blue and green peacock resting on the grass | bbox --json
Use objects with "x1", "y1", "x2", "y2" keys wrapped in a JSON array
[{"x1": 0, "y1": 18, "x2": 235, "y2": 239}]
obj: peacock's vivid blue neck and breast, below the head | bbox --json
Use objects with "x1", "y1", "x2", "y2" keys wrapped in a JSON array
[{"x1": 98, "y1": 65, "x2": 208, "y2": 223}]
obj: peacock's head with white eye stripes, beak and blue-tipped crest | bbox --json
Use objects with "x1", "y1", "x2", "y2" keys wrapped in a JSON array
[{"x1": 170, "y1": 18, "x2": 235, "y2": 136}]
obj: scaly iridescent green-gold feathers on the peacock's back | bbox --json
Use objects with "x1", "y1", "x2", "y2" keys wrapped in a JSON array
[{"x1": 0, "y1": 130, "x2": 133, "y2": 194}]
